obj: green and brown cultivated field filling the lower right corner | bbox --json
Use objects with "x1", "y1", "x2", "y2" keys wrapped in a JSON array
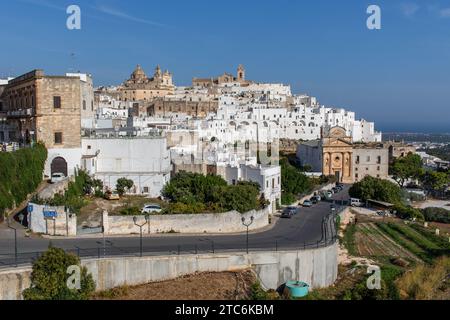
[{"x1": 306, "y1": 216, "x2": 450, "y2": 300}]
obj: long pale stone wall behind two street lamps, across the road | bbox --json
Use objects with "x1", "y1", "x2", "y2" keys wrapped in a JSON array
[{"x1": 103, "y1": 207, "x2": 270, "y2": 235}]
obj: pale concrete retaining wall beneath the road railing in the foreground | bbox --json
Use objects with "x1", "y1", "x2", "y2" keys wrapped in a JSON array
[{"x1": 0, "y1": 244, "x2": 338, "y2": 300}]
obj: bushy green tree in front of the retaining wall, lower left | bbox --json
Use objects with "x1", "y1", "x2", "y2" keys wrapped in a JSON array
[{"x1": 23, "y1": 247, "x2": 95, "y2": 300}]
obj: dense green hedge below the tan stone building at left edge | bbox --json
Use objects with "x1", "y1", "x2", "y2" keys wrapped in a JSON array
[{"x1": 0, "y1": 144, "x2": 47, "y2": 220}]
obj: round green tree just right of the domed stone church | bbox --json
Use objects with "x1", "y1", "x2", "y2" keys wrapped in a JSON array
[{"x1": 391, "y1": 153, "x2": 423, "y2": 187}]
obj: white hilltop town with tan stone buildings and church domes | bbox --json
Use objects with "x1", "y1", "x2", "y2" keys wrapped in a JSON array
[{"x1": 0, "y1": 65, "x2": 389, "y2": 215}]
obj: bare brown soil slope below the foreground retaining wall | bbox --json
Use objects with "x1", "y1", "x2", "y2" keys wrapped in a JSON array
[{"x1": 93, "y1": 270, "x2": 256, "y2": 300}]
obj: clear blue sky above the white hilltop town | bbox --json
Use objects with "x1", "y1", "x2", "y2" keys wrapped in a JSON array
[{"x1": 0, "y1": 0, "x2": 450, "y2": 132}]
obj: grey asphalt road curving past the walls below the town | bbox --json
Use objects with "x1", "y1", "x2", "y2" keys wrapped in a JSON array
[{"x1": 0, "y1": 188, "x2": 348, "y2": 267}]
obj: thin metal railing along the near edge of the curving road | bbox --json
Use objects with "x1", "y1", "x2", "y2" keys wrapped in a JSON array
[{"x1": 0, "y1": 206, "x2": 345, "y2": 269}]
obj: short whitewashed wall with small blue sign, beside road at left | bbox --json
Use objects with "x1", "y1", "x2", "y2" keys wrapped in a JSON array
[{"x1": 28, "y1": 203, "x2": 77, "y2": 236}]
